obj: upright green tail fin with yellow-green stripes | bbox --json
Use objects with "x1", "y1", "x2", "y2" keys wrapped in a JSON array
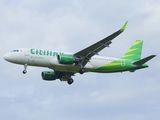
[{"x1": 122, "y1": 40, "x2": 143, "y2": 60}]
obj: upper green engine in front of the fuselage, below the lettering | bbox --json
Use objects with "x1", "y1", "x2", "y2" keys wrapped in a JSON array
[{"x1": 57, "y1": 54, "x2": 75, "y2": 64}]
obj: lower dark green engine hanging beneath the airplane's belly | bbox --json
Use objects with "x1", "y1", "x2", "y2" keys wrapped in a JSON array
[{"x1": 41, "y1": 71, "x2": 58, "y2": 81}]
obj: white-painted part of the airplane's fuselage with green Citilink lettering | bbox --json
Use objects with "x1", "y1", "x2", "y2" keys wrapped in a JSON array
[{"x1": 4, "y1": 48, "x2": 117, "y2": 73}]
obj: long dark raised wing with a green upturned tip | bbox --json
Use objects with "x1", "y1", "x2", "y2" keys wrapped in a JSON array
[{"x1": 74, "y1": 21, "x2": 128, "y2": 66}]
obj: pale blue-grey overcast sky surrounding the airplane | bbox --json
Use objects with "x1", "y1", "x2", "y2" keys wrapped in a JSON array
[{"x1": 0, "y1": 0, "x2": 160, "y2": 120}]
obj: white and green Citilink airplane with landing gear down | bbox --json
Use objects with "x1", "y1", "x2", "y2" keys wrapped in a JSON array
[{"x1": 4, "y1": 21, "x2": 156, "y2": 85}]
